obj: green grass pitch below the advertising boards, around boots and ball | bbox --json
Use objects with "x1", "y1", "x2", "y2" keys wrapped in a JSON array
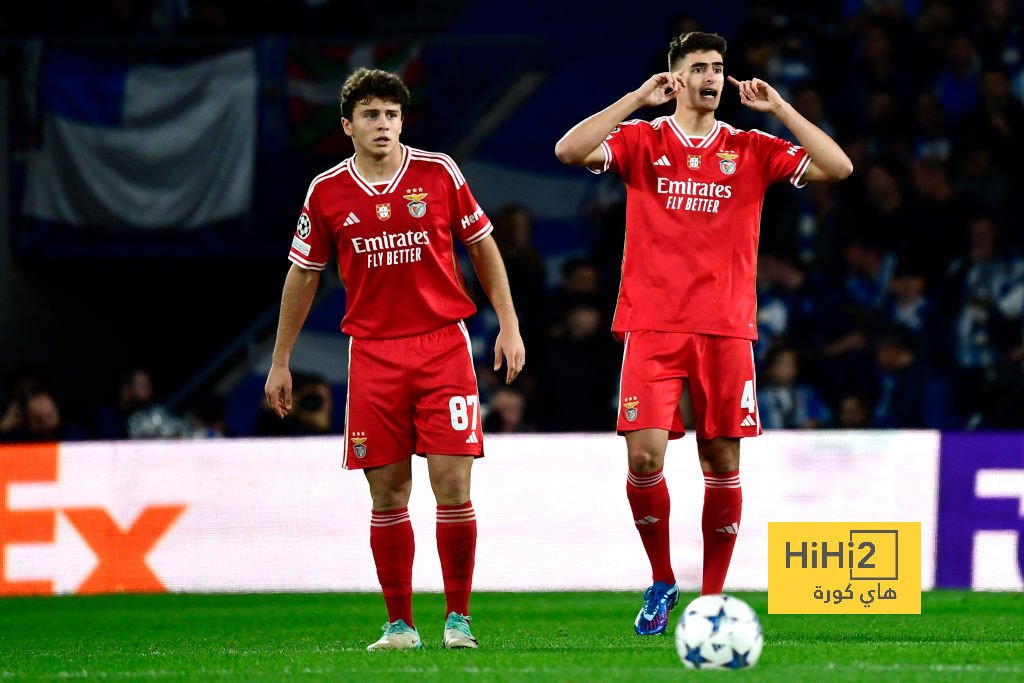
[{"x1": 0, "y1": 591, "x2": 1024, "y2": 681}]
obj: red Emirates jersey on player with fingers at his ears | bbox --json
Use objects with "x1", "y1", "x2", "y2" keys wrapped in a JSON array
[{"x1": 596, "y1": 117, "x2": 811, "y2": 339}]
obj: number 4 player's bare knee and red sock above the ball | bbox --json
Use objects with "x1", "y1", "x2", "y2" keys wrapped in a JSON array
[{"x1": 697, "y1": 436, "x2": 743, "y2": 595}]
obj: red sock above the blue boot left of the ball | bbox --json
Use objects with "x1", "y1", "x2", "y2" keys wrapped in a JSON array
[{"x1": 626, "y1": 469, "x2": 676, "y2": 585}]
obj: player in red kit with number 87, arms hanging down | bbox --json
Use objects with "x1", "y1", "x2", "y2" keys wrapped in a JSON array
[{"x1": 265, "y1": 69, "x2": 525, "y2": 650}]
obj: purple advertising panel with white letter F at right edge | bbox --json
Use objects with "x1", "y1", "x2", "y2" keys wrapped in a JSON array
[{"x1": 935, "y1": 434, "x2": 1024, "y2": 590}]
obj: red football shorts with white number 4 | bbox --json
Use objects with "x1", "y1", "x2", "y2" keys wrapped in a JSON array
[{"x1": 616, "y1": 331, "x2": 761, "y2": 439}]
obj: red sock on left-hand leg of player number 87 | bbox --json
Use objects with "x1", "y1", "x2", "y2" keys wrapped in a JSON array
[{"x1": 370, "y1": 508, "x2": 416, "y2": 628}]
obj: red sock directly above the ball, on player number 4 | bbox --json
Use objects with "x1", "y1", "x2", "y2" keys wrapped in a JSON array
[{"x1": 700, "y1": 470, "x2": 743, "y2": 595}]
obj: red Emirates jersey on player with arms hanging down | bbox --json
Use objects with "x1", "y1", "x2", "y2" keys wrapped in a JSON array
[{"x1": 288, "y1": 145, "x2": 492, "y2": 339}]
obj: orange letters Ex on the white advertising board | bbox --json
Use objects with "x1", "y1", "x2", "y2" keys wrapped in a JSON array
[{"x1": 0, "y1": 443, "x2": 186, "y2": 595}]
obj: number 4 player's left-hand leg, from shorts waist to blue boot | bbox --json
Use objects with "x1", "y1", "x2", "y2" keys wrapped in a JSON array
[{"x1": 617, "y1": 332, "x2": 684, "y2": 635}]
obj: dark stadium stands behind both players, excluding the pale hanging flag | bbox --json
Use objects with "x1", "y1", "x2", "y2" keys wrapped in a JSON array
[{"x1": 0, "y1": 0, "x2": 1024, "y2": 440}]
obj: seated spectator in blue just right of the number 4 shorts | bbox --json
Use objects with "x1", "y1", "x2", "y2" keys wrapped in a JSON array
[{"x1": 758, "y1": 345, "x2": 831, "y2": 429}]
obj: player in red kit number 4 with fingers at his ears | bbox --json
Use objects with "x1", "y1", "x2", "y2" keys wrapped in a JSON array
[{"x1": 555, "y1": 32, "x2": 853, "y2": 635}]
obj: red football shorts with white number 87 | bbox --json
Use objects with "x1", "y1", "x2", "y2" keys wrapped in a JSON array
[{"x1": 342, "y1": 321, "x2": 483, "y2": 470}]
